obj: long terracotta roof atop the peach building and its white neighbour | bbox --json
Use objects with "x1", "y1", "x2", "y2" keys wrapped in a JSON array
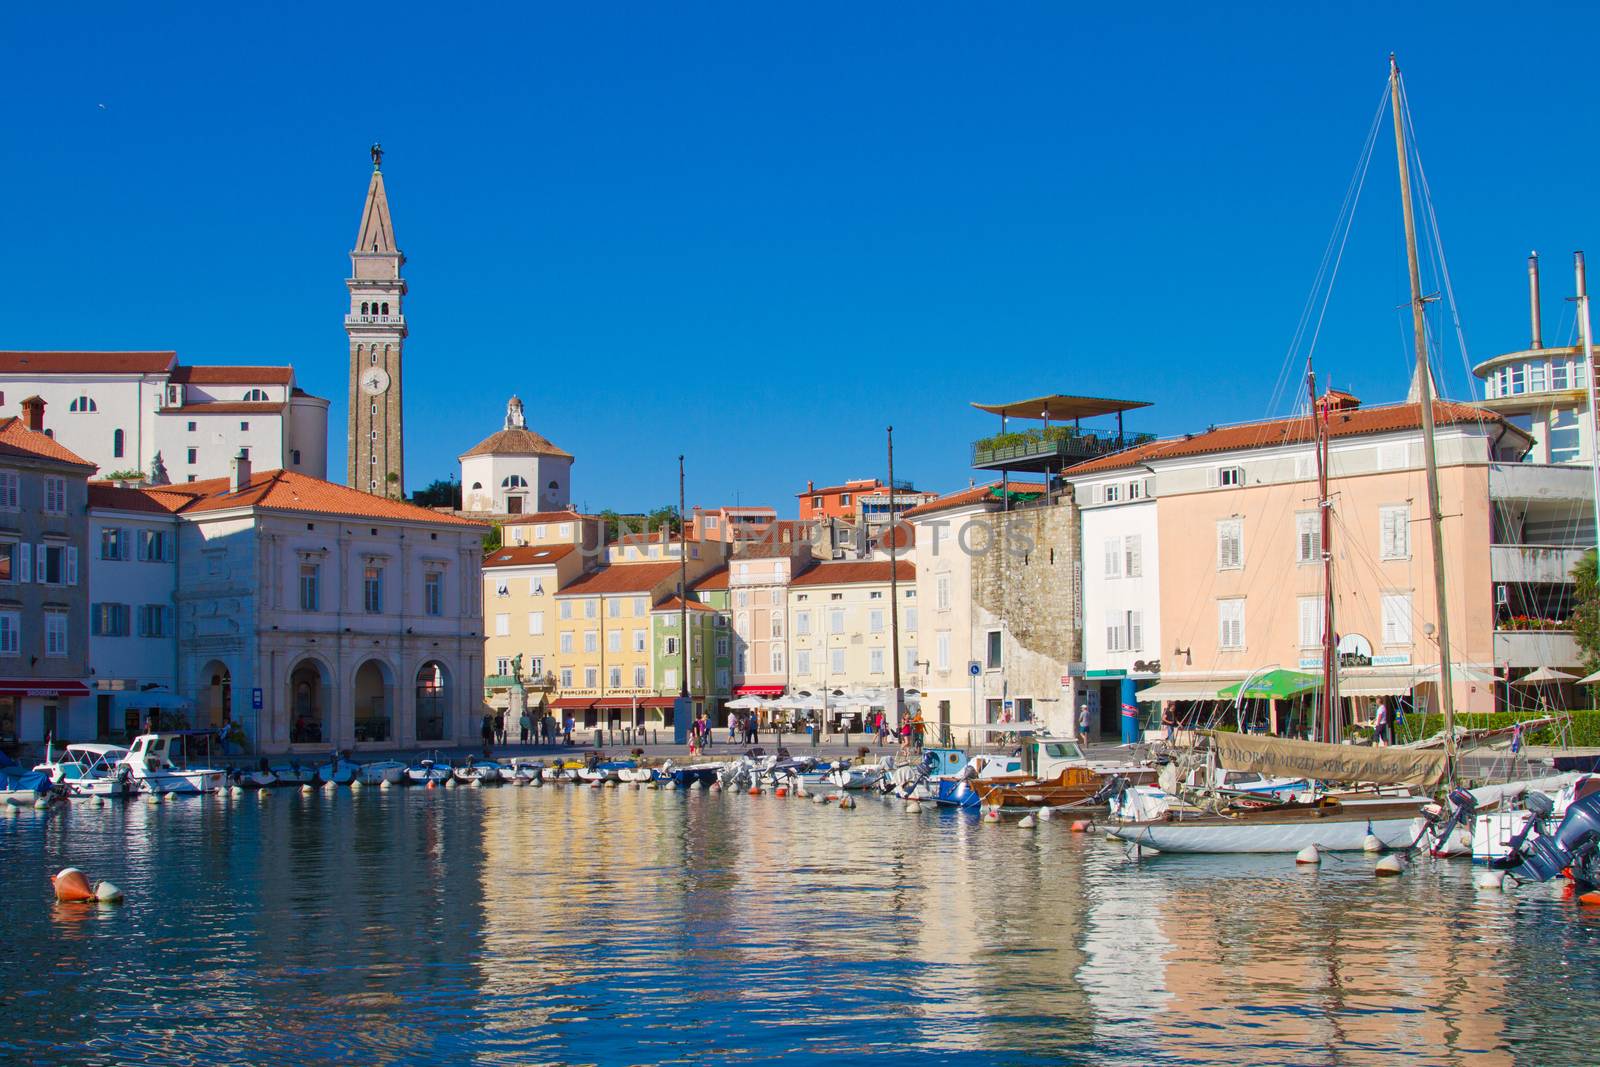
[{"x1": 1066, "y1": 400, "x2": 1522, "y2": 477}]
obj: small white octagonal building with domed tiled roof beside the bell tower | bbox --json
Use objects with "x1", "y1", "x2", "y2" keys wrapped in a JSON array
[{"x1": 461, "y1": 395, "x2": 573, "y2": 515}]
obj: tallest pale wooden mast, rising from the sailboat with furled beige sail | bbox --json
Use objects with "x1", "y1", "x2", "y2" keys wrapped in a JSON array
[{"x1": 1389, "y1": 53, "x2": 1456, "y2": 781}]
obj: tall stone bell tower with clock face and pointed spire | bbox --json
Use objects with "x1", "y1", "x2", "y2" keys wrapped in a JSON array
[{"x1": 344, "y1": 144, "x2": 406, "y2": 498}]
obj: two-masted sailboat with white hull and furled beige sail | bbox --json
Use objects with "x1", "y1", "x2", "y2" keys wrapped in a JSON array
[{"x1": 1107, "y1": 54, "x2": 1458, "y2": 853}]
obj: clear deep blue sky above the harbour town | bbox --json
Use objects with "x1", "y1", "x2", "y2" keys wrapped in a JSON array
[{"x1": 0, "y1": 3, "x2": 1600, "y2": 514}]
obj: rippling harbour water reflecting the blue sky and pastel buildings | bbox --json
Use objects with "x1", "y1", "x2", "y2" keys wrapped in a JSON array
[{"x1": 0, "y1": 787, "x2": 1600, "y2": 1064}]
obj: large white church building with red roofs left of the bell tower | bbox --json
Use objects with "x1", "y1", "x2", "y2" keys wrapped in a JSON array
[{"x1": 0, "y1": 352, "x2": 328, "y2": 482}]
